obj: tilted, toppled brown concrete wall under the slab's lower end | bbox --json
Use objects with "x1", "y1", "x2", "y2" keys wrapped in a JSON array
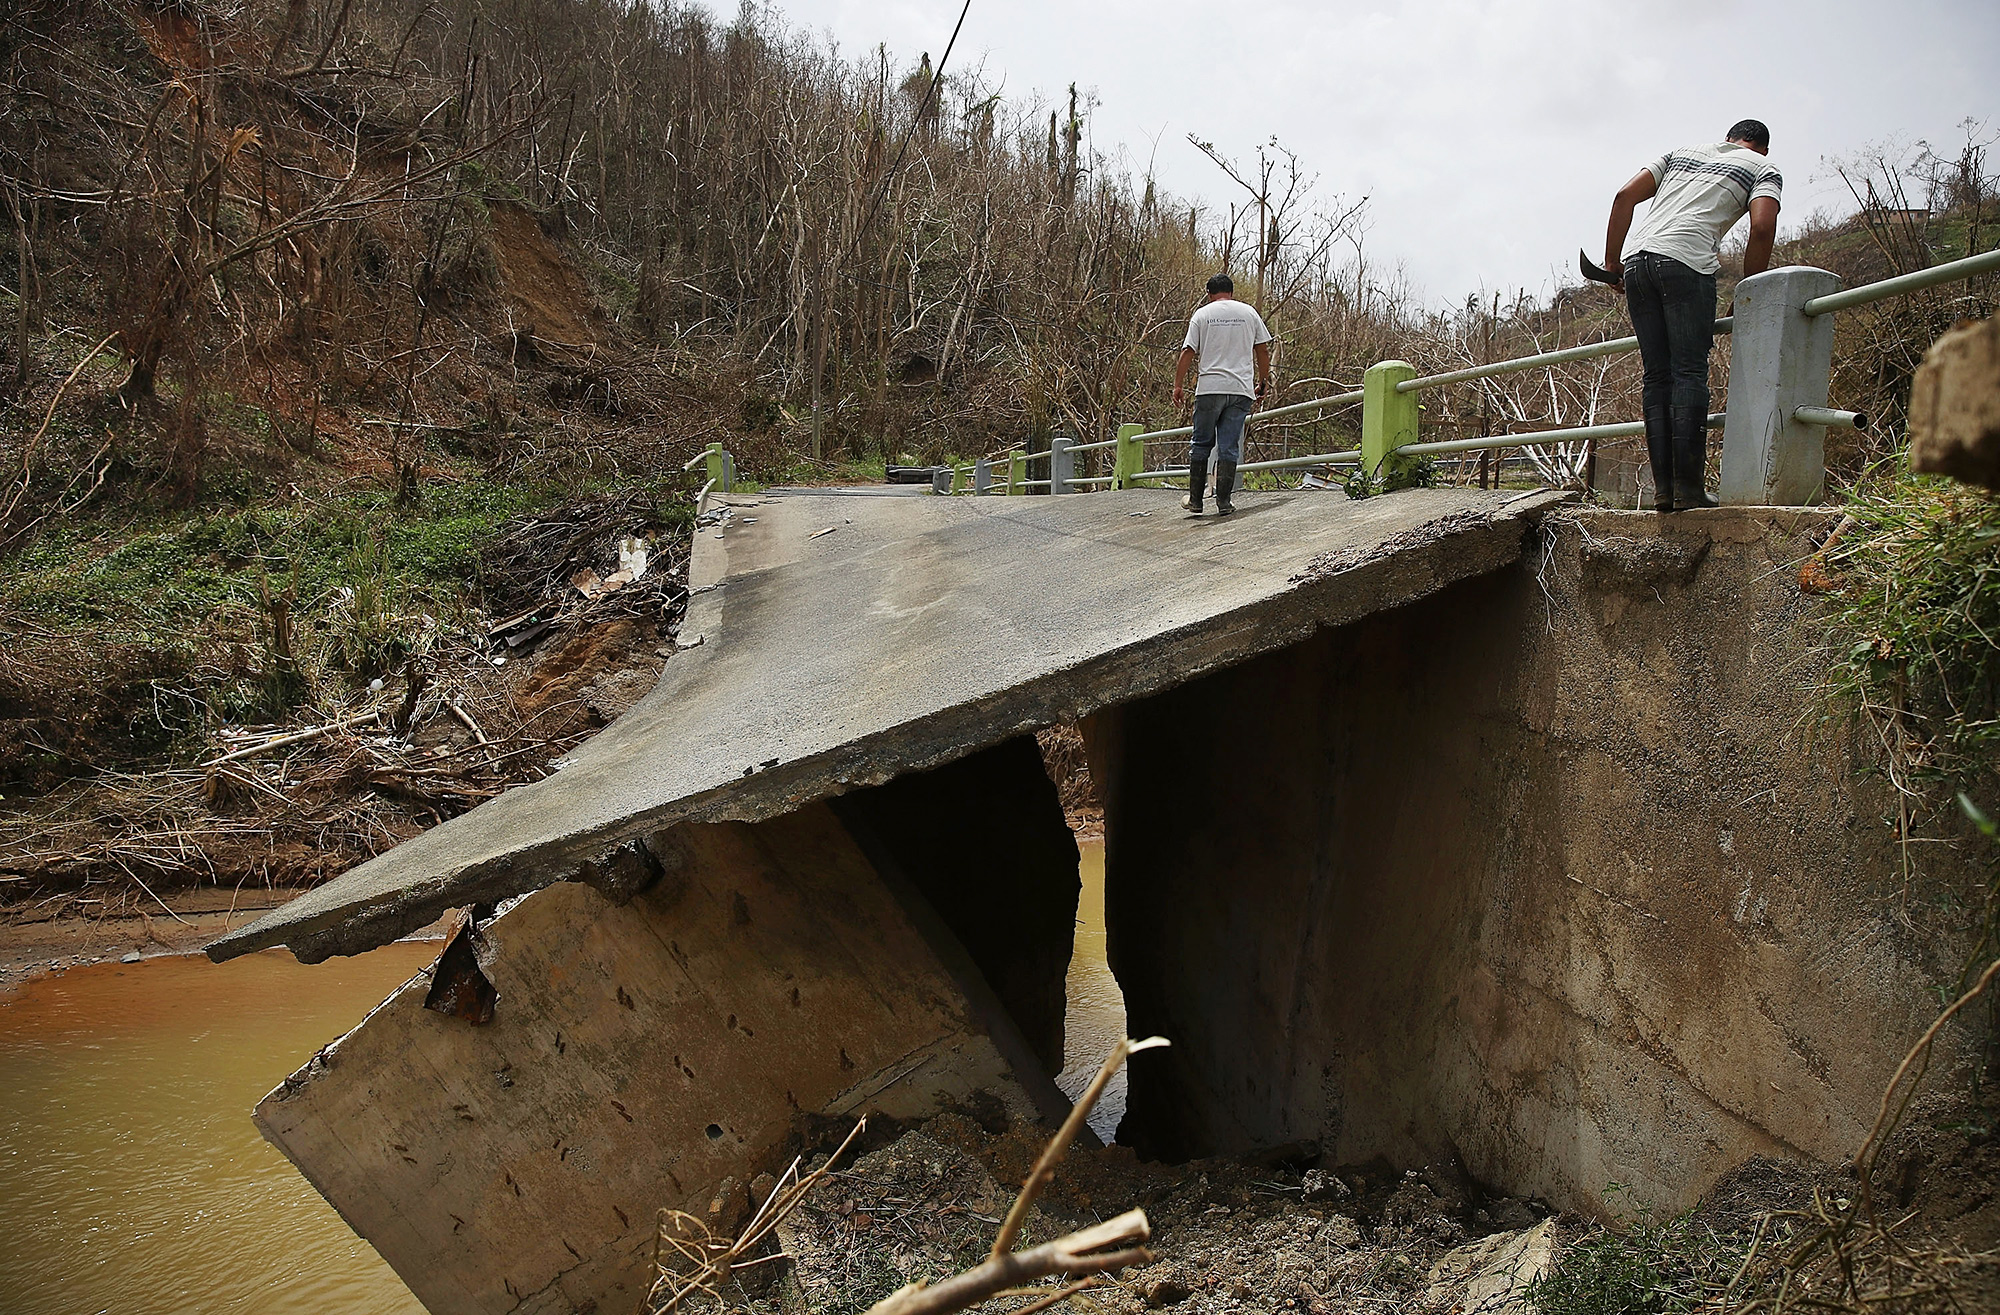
[{"x1": 270, "y1": 799, "x2": 1076, "y2": 1315}]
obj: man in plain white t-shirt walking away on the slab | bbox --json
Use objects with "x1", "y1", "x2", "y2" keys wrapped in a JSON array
[{"x1": 1174, "y1": 274, "x2": 1270, "y2": 516}]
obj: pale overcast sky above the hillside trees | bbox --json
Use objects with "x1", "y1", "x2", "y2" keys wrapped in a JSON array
[{"x1": 740, "y1": 0, "x2": 2000, "y2": 302}]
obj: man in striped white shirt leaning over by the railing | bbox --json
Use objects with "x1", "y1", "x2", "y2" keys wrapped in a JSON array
[{"x1": 1604, "y1": 118, "x2": 1784, "y2": 512}]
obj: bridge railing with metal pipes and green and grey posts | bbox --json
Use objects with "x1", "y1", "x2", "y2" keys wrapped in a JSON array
[{"x1": 700, "y1": 248, "x2": 2000, "y2": 506}]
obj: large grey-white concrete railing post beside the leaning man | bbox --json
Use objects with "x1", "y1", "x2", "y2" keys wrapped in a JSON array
[{"x1": 1722, "y1": 266, "x2": 1840, "y2": 508}]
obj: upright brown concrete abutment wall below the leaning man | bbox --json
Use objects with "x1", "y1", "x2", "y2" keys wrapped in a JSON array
[{"x1": 1086, "y1": 510, "x2": 1984, "y2": 1211}]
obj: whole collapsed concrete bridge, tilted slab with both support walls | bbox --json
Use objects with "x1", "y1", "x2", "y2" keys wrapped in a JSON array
[{"x1": 210, "y1": 490, "x2": 1968, "y2": 1313}]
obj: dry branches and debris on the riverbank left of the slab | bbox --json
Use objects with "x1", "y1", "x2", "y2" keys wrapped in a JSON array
[{"x1": 0, "y1": 485, "x2": 688, "y2": 901}]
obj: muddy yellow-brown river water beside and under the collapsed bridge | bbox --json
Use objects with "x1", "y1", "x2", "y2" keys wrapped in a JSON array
[{"x1": 0, "y1": 841, "x2": 1124, "y2": 1315}]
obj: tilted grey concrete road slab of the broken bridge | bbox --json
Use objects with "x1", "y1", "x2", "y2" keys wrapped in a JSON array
[{"x1": 208, "y1": 490, "x2": 1562, "y2": 961}]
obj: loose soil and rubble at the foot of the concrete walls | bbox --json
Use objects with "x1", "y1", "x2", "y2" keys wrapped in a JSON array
[{"x1": 664, "y1": 1099, "x2": 2000, "y2": 1315}]
